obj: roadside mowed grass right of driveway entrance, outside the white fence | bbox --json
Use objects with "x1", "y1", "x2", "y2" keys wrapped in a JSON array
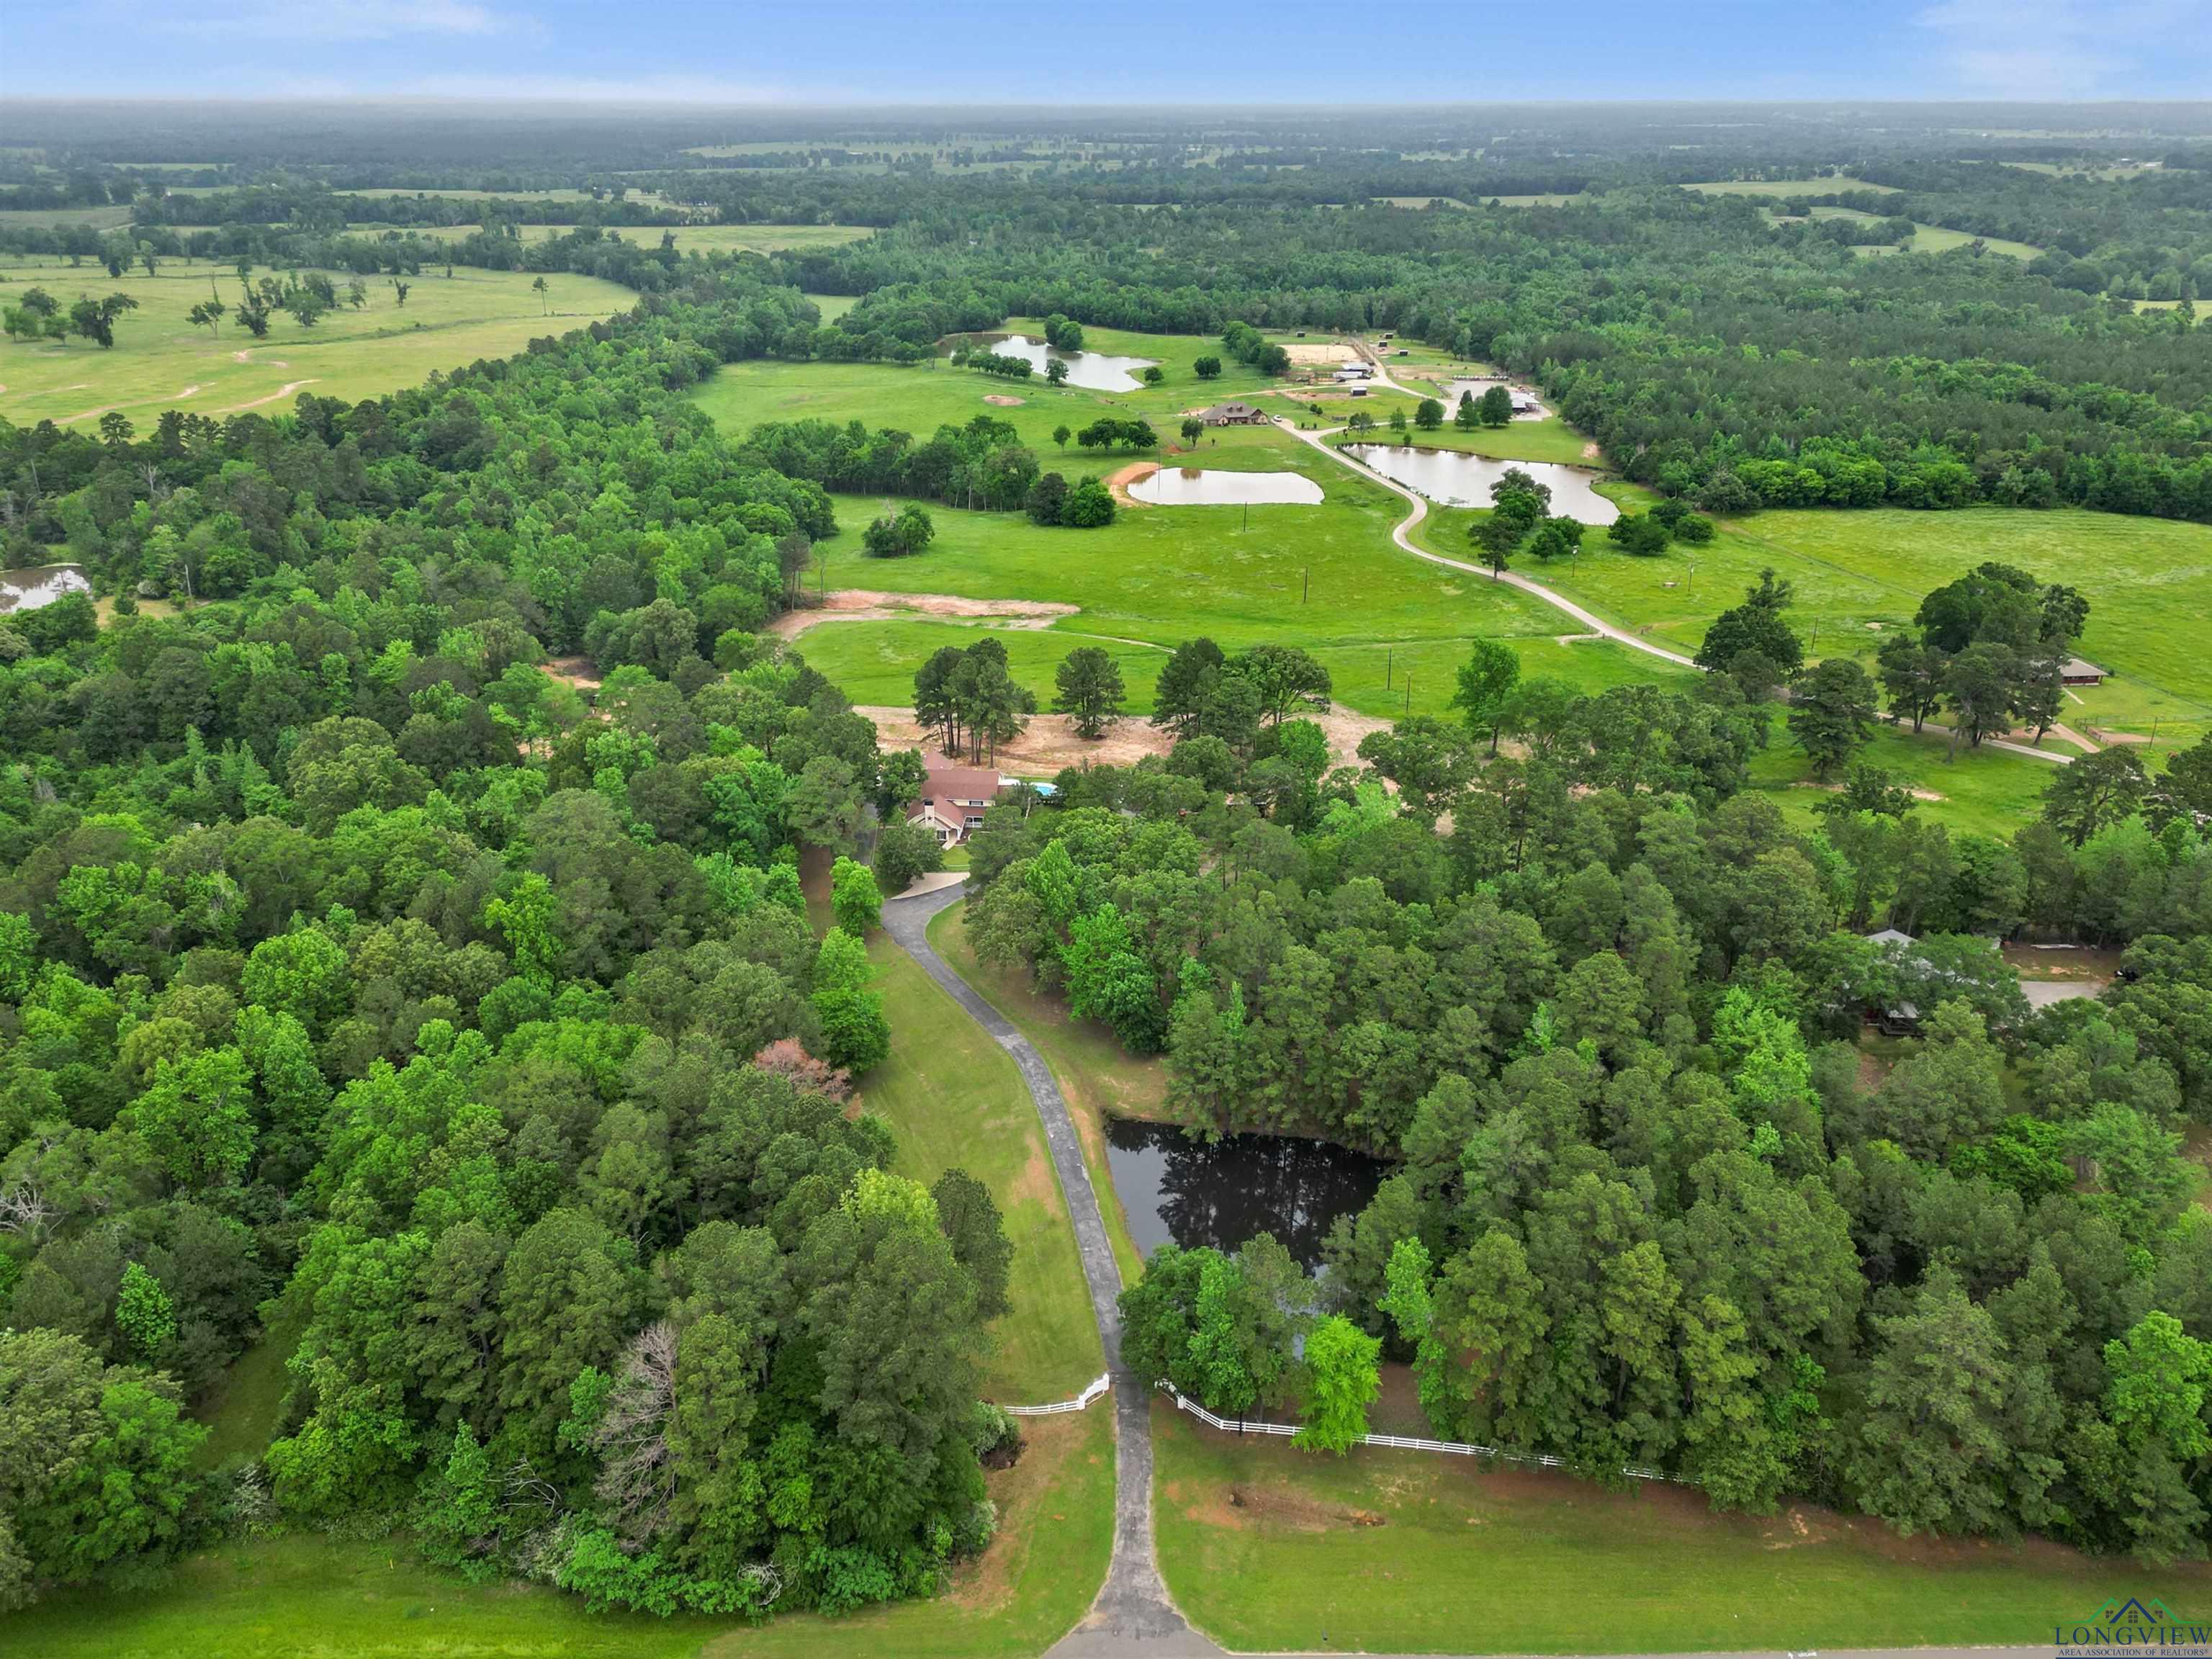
[{"x1": 1153, "y1": 1403, "x2": 2212, "y2": 1653}]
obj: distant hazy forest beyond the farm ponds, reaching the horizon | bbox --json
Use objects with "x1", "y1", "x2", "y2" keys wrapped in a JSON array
[{"x1": 17, "y1": 104, "x2": 2212, "y2": 522}]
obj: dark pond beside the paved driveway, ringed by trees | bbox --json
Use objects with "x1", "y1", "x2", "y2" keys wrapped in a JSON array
[{"x1": 1106, "y1": 1117, "x2": 1389, "y2": 1272}]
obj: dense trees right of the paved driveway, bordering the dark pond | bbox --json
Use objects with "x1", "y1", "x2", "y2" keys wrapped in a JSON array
[{"x1": 969, "y1": 646, "x2": 2212, "y2": 1560}]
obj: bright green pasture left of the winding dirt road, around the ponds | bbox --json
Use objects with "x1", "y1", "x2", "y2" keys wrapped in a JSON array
[{"x1": 699, "y1": 330, "x2": 1648, "y2": 714}]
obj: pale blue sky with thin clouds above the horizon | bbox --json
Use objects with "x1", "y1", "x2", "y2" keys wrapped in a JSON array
[{"x1": 0, "y1": 0, "x2": 2212, "y2": 106}]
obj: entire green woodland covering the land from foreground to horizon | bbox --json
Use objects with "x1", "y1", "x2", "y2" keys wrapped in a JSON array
[{"x1": 0, "y1": 106, "x2": 2212, "y2": 1615}]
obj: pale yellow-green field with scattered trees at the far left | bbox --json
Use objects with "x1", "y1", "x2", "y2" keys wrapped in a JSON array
[{"x1": 0, "y1": 258, "x2": 637, "y2": 431}]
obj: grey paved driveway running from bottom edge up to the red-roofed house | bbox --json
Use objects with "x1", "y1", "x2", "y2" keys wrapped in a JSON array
[{"x1": 883, "y1": 885, "x2": 1221, "y2": 1659}]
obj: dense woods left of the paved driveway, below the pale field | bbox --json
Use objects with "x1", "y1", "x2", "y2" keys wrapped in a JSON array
[{"x1": 0, "y1": 279, "x2": 1026, "y2": 1615}]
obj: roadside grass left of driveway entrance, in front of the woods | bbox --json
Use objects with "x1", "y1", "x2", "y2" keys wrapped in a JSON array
[{"x1": 0, "y1": 1407, "x2": 1112, "y2": 1659}]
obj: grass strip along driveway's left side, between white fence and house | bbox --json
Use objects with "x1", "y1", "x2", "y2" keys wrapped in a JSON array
[{"x1": 858, "y1": 942, "x2": 1106, "y2": 1405}]
